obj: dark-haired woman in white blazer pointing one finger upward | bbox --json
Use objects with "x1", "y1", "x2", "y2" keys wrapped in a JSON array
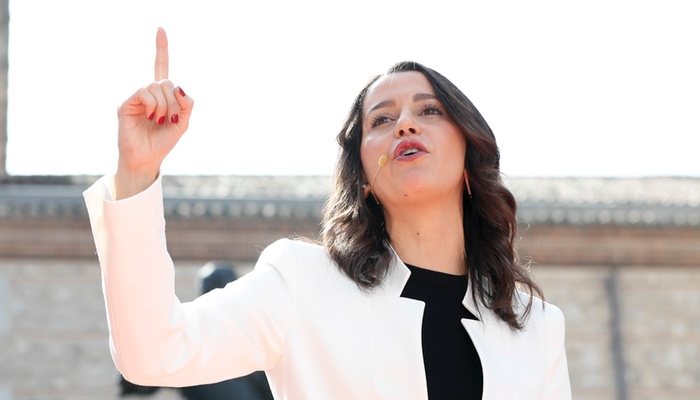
[{"x1": 85, "y1": 30, "x2": 571, "y2": 400}]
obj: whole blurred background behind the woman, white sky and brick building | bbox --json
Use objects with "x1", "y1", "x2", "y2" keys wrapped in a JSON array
[{"x1": 0, "y1": 0, "x2": 700, "y2": 400}]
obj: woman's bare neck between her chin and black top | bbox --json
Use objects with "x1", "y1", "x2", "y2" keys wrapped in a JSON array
[{"x1": 385, "y1": 195, "x2": 467, "y2": 275}]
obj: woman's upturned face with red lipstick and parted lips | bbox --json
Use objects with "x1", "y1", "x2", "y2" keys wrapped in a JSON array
[{"x1": 360, "y1": 71, "x2": 466, "y2": 204}]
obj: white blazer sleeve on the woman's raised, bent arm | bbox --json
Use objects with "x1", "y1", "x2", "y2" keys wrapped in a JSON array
[{"x1": 84, "y1": 177, "x2": 295, "y2": 386}]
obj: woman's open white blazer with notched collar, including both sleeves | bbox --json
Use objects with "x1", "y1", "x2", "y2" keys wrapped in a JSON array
[{"x1": 84, "y1": 177, "x2": 571, "y2": 400}]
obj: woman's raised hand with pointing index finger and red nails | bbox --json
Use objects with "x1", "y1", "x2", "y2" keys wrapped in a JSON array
[{"x1": 115, "y1": 28, "x2": 194, "y2": 199}]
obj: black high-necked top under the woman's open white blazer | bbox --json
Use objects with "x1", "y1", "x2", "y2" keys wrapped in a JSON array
[{"x1": 401, "y1": 264, "x2": 483, "y2": 400}]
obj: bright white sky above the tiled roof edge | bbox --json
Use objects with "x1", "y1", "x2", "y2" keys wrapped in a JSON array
[{"x1": 7, "y1": 0, "x2": 700, "y2": 177}]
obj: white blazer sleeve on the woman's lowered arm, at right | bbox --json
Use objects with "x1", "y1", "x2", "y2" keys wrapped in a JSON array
[{"x1": 542, "y1": 303, "x2": 571, "y2": 400}]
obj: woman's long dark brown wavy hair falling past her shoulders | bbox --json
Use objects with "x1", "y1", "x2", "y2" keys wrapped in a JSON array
[{"x1": 321, "y1": 62, "x2": 543, "y2": 329}]
